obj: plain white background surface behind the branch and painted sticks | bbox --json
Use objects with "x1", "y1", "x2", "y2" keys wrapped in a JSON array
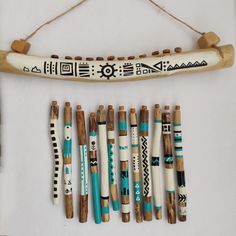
[{"x1": 0, "y1": 0, "x2": 236, "y2": 236}]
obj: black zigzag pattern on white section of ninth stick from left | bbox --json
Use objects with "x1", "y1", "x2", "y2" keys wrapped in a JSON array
[{"x1": 141, "y1": 136, "x2": 150, "y2": 197}]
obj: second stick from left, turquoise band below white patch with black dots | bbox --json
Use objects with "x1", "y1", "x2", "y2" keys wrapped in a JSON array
[{"x1": 63, "y1": 102, "x2": 73, "y2": 219}]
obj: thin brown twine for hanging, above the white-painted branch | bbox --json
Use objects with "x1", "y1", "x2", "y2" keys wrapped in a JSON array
[{"x1": 24, "y1": 0, "x2": 204, "y2": 41}]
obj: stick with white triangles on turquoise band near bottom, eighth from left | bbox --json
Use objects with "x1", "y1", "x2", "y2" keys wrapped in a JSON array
[{"x1": 130, "y1": 108, "x2": 142, "y2": 223}]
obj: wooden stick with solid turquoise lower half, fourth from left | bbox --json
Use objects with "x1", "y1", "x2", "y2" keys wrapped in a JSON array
[{"x1": 89, "y1": 113, "x2": 102, "y2": 224}]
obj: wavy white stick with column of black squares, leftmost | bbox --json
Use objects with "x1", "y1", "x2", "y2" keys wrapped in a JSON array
[{"x1": 50, "y1": 101, "x2": 63, "y2": 205}]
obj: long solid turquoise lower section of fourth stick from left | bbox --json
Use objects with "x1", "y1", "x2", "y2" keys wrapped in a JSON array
[{"x1": 91, "y1": 173, "x2": 102, "y2": 224}]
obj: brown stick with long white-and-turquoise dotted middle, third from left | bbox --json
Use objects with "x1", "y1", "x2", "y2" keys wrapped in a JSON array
[{"x1": 76, "y1": 105, "x2": 88, "y2": 223}]
